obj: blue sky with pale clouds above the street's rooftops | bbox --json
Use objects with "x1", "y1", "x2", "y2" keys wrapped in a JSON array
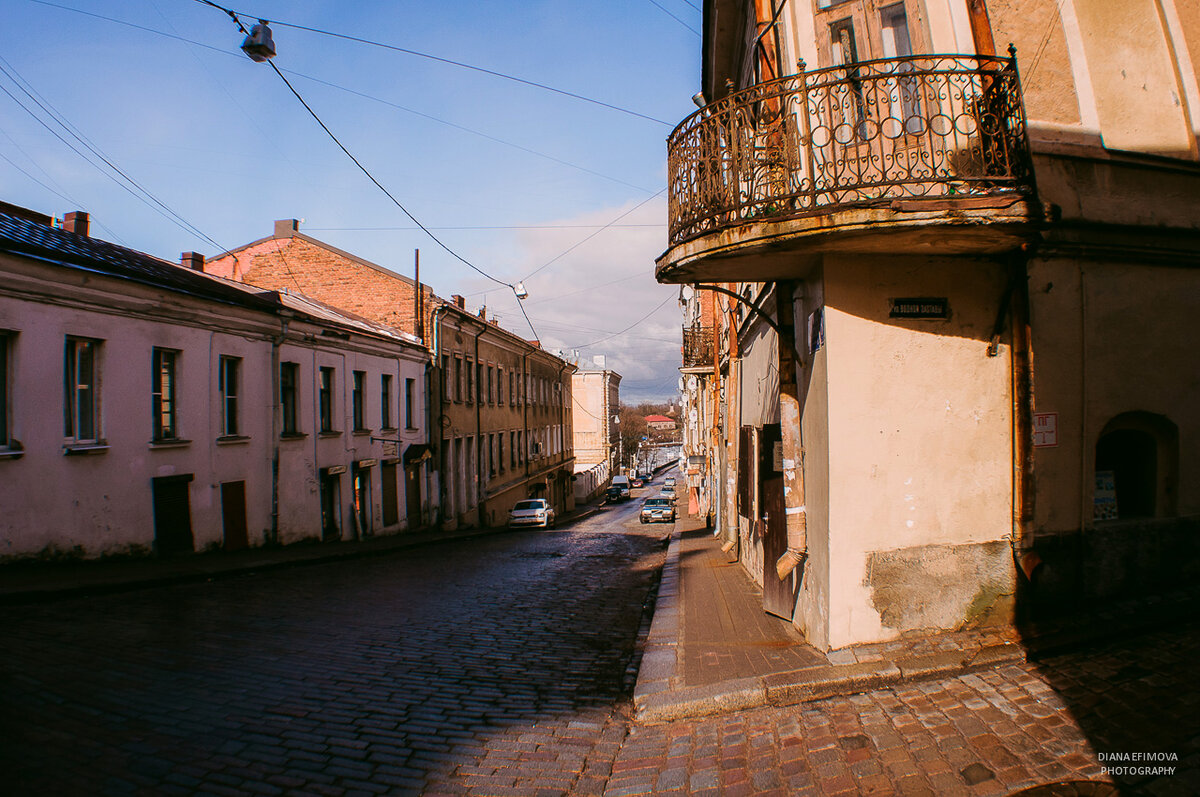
[{"x1": 0, "y1": 0, "x2": 701, "y2": 403}]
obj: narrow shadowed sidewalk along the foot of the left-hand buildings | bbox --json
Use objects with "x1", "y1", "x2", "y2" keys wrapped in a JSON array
[{"x1": 0, "y1": 503, "x2": 598, "y2": 605}]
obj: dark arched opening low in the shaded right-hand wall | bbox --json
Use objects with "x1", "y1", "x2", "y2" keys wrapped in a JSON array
[{"x1": 1094, "y1": 412, "x2": 1178, "y2": 520}]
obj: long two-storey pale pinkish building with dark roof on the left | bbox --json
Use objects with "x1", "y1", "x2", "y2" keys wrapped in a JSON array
[{"x1": 0, "y1": 206, "x2": 432, "y2": 558}]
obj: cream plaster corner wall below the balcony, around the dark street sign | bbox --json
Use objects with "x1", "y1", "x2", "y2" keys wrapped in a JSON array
[{"x1": 826, "y1": 259, "x2": 1013, "y2": 648}]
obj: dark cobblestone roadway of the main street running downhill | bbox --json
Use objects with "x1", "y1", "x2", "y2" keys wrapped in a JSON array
[{"x1": 0, "y1": 503, "x2": 666, "y2": 796}]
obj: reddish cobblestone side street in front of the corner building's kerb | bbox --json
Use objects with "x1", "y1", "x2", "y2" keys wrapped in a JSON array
[{"x1": 605, "y1": 625, "x2": 1200, "y2": 797}]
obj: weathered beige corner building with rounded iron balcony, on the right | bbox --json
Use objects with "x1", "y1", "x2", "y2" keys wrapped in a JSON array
[{"x1": 656, "y1": 0, "x2": 1200, "y2": 648}]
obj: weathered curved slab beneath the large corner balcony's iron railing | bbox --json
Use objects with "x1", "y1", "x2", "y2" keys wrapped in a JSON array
[{"x1": 655, "y1": 193, "x2": 1040, "y2": 283}]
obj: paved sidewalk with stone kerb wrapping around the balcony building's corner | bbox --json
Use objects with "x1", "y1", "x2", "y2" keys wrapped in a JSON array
[{"x1": 634, "y1": 515, "x2": 1195, "y2": 723}]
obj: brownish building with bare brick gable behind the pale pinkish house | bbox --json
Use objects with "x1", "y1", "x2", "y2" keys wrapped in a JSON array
[{"x1": 204, "y1": 220, "x2": 574, "y2": 529}]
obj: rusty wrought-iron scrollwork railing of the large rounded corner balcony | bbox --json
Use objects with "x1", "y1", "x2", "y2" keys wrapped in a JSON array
[{"x1": 667, "y1": 55, "x2": 1032, "y2": 246}]
